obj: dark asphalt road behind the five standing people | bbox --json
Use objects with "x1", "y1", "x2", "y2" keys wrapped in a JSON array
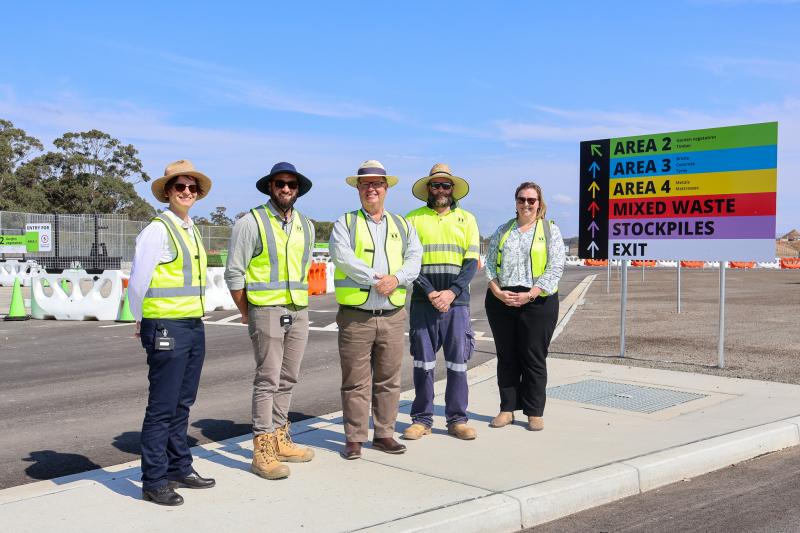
[{"x1": 0, "y1": 267, "x2": 589, "y2": 489}]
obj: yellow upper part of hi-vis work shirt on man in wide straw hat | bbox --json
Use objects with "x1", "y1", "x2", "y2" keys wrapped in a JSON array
[{"x1": 406, "y1": 206, "x2": 480, "y2": 276}]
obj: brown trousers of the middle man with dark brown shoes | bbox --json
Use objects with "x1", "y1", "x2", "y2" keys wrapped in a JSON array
[{"x1": 336, "y1": 306, "x2": 406, "y2": 443}]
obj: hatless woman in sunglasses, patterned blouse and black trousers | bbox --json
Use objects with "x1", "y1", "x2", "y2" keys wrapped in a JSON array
[{"x1": 486, "y1": 182, "x2": 565, "y2": 431}]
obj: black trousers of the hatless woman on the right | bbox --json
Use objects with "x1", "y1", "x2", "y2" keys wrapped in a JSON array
[{"x1": 485, "y1": 287, "x2": 558, "y2": 416}]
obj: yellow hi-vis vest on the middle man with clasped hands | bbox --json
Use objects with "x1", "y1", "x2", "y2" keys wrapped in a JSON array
[{"x1": 333, "y1": 209, "x2": 408, "y2": 307}]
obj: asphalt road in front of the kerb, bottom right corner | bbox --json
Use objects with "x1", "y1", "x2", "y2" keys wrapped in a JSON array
[{"x1": 527, "y1": 447, "x2": 800, "y2": 533}]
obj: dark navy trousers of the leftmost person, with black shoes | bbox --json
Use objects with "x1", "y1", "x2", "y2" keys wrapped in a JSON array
[{"x1": 141, "y1": 318, "x2": 206, "y2": 490}]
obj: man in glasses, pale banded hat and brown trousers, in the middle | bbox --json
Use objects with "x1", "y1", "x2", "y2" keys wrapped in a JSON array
[{"x1": 330, "y1": 160, "x2": 422, "y2": 459}]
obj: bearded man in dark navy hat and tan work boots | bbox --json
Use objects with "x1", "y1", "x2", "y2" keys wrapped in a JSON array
[{"x1": 225, "y1": 162, "x2": 315, "y2": 479}]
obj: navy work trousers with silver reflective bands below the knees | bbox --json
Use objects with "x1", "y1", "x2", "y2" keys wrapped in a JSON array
[{"x1": 408, "y1": 301, "x2": 475, "y2": 427}]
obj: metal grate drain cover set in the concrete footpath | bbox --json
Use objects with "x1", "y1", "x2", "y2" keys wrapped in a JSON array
[{"x1": 547, "y1": 379, "x2": 706, "y2": 413}]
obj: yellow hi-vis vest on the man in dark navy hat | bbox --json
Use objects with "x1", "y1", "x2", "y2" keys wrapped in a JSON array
[{"x1": 244, "y1": 205, "x2": 314, "y2": 307}]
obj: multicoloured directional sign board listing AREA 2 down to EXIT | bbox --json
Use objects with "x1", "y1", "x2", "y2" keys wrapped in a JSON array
[{"x1": 578, "y1": 122, "x2": 778, "y2": 261}]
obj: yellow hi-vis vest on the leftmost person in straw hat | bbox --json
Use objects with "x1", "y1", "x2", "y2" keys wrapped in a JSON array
[{"x1": 142, "y1": 213, "x2": 207, "y2": 318}]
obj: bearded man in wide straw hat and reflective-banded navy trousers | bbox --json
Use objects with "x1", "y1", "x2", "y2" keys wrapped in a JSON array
[{"x1": 403, "y1": 163, "x2": 480, "y2": 440}]
